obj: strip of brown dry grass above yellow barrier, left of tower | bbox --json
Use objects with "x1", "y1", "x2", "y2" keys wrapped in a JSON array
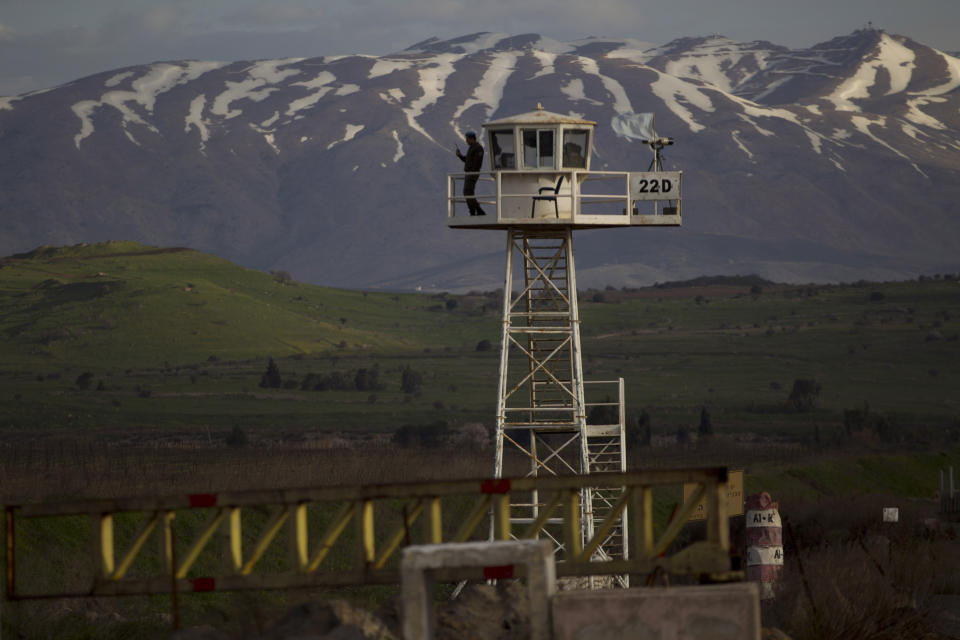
[{"x1": 0, "y1": 442, "x2": 492, "y2": 504}]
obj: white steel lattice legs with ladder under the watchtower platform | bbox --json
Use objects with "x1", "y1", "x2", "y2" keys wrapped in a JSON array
[{"x1": 494, "y1": 227, "x2": 594, "y2": 547}]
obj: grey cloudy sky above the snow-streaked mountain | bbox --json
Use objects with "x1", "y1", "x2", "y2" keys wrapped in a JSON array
[{"x1": 0, "y1": 0, "x2": 960, "y2": 96}]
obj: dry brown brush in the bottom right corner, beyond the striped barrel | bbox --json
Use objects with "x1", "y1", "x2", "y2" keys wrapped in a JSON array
[{"x1": 764, "y1": 496, "x2": 960, "y2": 640}]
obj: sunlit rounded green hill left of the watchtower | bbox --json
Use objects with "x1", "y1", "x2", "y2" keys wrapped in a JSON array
[{"x1": 0, "y1": 242, "x2": 496, "y2": 370}]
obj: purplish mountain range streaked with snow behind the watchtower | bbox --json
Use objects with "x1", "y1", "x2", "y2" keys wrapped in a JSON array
[{"x1": 0, "y1": 30, "x2": 960, "y2": 289}]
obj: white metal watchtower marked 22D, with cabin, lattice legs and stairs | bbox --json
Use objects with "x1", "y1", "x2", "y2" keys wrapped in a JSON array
[{"x1": 447, "y1": 107, "x2": 682, "y2": 576}]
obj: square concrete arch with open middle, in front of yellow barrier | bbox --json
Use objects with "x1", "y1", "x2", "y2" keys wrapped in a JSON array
[{"x1": 400, "y1": 540, "x2": 557, "y2": 640}]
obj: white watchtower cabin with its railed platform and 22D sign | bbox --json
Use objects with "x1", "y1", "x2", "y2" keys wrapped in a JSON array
[{"x1": 447, "y1": 109, "x2": 682, "y2": 229}]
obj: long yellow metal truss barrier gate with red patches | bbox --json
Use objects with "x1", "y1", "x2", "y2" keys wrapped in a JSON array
[{"x1": 4, "y1": 468, "x2": 731, "y2": 600}]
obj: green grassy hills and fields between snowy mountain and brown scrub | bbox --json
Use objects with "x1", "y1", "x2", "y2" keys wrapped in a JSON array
[{"x1": 0, "y1": 242, "x2": 960, "y2": 450}]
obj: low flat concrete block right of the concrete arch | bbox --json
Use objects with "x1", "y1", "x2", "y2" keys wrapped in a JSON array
[{"x1": 551, "y1": 583, "x2": 760, "y2": 640}]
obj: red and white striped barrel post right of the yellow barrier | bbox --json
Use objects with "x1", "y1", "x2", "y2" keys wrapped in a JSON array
[{"x1": 745, "y1": 492, "x2": 783, "y2": 598}]
